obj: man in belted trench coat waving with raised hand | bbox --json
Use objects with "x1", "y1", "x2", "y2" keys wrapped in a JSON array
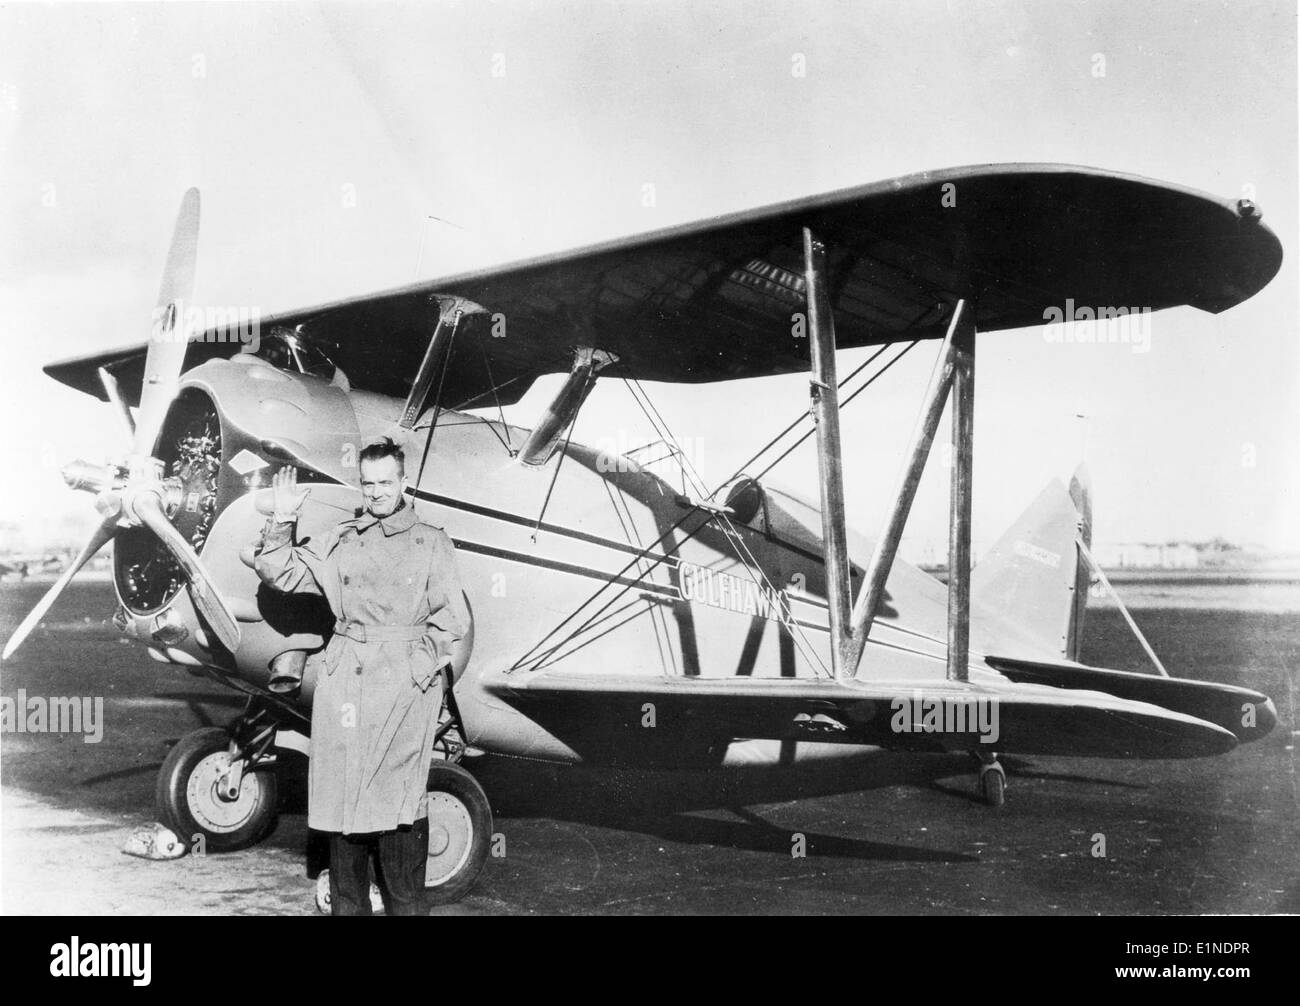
[{"x1": 255, "y1": 439, "x2": 469, "y2": 915}]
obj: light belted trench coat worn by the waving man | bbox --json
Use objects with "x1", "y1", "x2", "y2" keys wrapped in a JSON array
[{"x1": 254, "y1": 503, "x2": 469, "y2": 834}]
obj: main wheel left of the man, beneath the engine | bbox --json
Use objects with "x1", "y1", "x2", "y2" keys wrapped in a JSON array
[{"x1": 155, "y1": 727, "x2": 277, "y2": 853}]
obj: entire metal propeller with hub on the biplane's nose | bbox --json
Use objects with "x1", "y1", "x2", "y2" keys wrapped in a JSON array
[{"x1": 0, "y1": 188, "x2": 241, "y2": 660}]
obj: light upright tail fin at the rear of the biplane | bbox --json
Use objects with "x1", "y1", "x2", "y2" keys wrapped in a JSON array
[{"x1": 971, "y1": 465, "x2": 1092, "y2": 660}]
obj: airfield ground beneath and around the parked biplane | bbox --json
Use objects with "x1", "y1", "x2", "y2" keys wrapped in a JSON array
[{"x1": 0, "y1": 577, "x2": 1300, "y2": 915}]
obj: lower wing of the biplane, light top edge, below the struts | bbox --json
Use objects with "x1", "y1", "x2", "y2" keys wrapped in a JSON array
[{"x1": 485, "y1": 671, "x2": 1236, "y2": 758}]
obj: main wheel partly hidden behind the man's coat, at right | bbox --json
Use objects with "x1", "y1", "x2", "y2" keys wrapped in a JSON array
[{"x1": 424, "y1": 762, "x2": 493, "y2": 905}]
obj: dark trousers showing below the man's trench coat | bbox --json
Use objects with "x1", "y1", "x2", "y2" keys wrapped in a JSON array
[{"x1": 329, "y1": 816, "x2": 429, "y2": 915}]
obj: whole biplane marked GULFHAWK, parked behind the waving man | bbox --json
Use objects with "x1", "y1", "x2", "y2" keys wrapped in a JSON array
[{"x1": 4, "y1": 165, "x2": 1282, "y2": 899}]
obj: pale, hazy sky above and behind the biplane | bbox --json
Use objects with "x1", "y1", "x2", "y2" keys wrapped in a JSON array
[{"x1": 0, "y1": 0, "x2": 1300, "y2": 555}]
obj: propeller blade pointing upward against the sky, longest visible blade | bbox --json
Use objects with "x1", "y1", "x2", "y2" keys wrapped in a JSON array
[{"x1": 134, "y1": 188, "x2": 199, "y2": 456}]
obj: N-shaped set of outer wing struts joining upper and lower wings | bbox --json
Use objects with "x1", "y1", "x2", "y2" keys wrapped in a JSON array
[{"x1": 803, "y1": 227, "x2": 975, "y2": 681}]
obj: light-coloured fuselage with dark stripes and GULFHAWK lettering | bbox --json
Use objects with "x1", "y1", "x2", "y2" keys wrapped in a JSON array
[{"x1": 106, "y1": 357, "x2": 1029, "y2": 764}]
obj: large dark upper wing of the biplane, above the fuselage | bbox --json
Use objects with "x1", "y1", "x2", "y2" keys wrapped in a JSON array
[{"x1": 46, "y1": 165, "x2": 1282, "y2": 407}]
